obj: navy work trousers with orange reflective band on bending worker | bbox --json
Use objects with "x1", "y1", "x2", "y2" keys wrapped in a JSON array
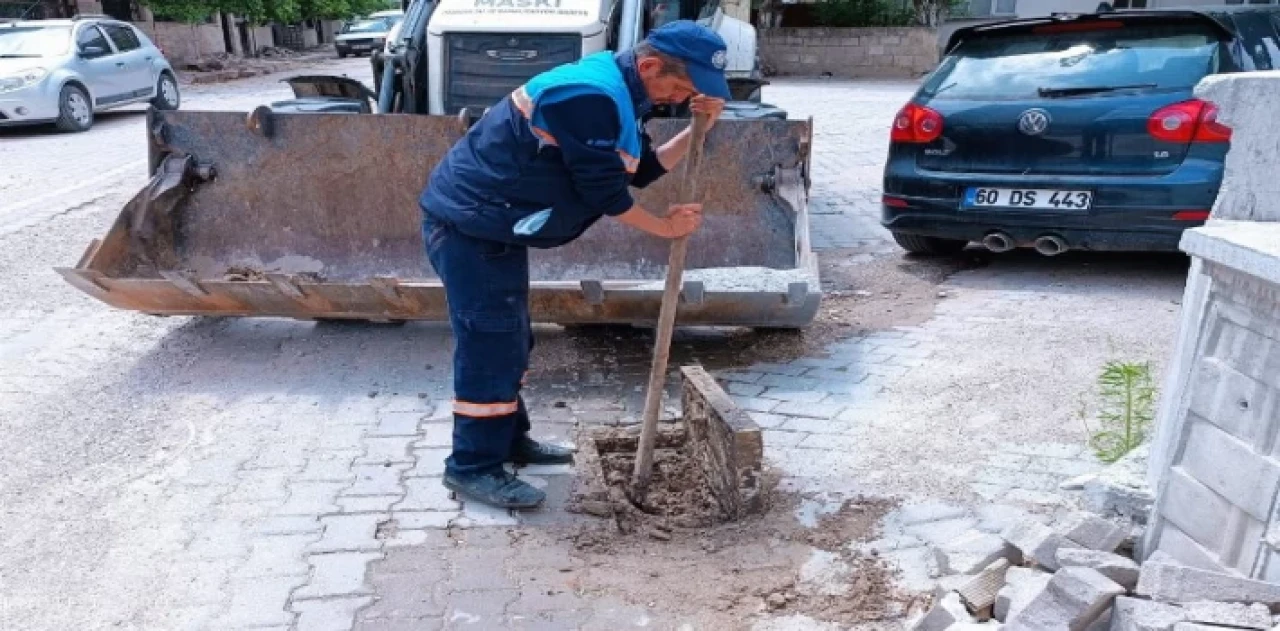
[{"x1": 422, "y1": 216, "x2": 534, "y2": 474}]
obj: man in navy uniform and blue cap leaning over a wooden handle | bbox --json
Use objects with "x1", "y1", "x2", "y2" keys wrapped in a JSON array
[{"x1": 420, "y1": 20, "x2": 730, "y2": 508}]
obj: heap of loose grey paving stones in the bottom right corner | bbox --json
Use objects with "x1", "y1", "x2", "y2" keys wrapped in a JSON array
[{"x1": 908, "y1": 512, "x2": 1280, "y2": 631}]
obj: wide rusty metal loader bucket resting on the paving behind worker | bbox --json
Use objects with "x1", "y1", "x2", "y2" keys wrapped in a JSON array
[{"x1": 58, "y1": 108, "x2": 822, "y2": 328}]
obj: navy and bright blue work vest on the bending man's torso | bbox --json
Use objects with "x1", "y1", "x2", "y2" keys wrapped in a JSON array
[{"x1": 419, "y1": 51, "x2": 643, "y2": 247}]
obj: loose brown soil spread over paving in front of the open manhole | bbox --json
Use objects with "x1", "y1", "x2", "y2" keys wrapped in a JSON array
[{"x1": 550, "y1": 476, "x2": 911, "y2": 630}]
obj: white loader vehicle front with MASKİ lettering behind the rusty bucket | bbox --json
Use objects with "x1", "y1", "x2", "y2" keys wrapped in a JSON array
[{"x1": 374, "y1": 0, "x2": 768, "y2": 116}]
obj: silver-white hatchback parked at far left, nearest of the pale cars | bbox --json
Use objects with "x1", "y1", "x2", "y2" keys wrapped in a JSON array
[{"x1": 0, "y1": 15, "x2": 182, "y2": 132}]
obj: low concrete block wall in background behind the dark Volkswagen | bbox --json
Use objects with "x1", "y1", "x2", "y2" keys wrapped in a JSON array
[{"x1": 759, "y1": 27, "x2": 938, "y2": 78}]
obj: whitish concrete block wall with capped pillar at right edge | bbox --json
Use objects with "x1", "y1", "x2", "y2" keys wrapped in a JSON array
[{"x1": 1144, "y1": 72, "x2": 1280, "y2": 581}]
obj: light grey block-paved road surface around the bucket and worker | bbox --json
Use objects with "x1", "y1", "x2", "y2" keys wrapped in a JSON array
[{"x1": 0, "y1": 66, "x2": 1184, "y2": 630}]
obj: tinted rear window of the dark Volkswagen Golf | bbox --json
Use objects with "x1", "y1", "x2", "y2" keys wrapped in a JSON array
[{"x1": 923, "y1": 24, "x2": 1219, "y2": 100}]
